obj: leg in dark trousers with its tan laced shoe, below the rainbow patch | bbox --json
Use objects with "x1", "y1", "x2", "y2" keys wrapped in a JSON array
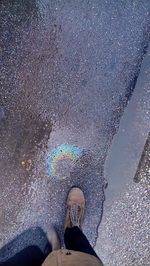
[{"x1": 64, "y1": 187, "x2": 100, "y2": 260}]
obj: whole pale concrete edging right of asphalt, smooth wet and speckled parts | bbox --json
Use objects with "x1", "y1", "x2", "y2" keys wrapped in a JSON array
[{"x1": 95, "y1": 46, "x2": 150, "y2": 266}]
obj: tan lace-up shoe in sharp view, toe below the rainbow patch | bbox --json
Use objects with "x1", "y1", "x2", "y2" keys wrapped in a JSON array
[{"x1": 64, "y1": 187, "x2": 85, "y2": 230}]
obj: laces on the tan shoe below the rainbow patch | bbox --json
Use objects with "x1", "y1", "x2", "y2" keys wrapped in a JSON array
[{"x1": 69, "y1": 203, "x2": 80, "y2": 227}]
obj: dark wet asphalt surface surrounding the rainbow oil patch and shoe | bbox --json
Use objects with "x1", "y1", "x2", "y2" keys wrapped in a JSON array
[{"x1": 0, "y1": 1, "x2": 150, "y2": 262}]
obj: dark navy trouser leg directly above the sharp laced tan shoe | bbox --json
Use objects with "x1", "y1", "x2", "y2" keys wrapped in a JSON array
[{"x1": 64, "y1": 226, "x2": 99, "y2": 259}]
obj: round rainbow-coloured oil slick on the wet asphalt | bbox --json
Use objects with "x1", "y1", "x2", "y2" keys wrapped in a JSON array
[{"x1": 47, "y1": 144, "x2": 82, "y2": 179}]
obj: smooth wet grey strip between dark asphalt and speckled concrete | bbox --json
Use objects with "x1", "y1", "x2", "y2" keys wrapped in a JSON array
[{"x1": 104, "y1": 43, "x2": 150, "y2": 206}]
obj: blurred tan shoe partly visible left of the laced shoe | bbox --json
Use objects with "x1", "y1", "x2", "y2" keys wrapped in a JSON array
[{"x1": 47, "y1": 228, "x2": 61, "y2": 251}]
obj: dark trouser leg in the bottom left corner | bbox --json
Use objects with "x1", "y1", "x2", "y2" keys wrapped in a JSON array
[{"x1": 0, "y1": 246, "x2": 47, "y2": 266}]
